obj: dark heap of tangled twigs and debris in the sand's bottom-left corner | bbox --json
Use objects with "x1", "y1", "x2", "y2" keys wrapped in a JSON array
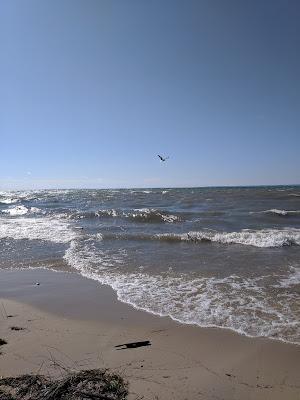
[{"x1": 0, "y1": 369, "x2": 128, "y2": 400}]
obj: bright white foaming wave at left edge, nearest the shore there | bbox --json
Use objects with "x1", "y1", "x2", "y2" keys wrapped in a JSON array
[{"x1": 0, "y1": 217, "x2": 79, "y2": 243}]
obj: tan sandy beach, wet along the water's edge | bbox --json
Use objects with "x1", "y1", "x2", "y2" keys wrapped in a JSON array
[{"x1": 0, "y1": 270, "x2": 300, "y2": 400}]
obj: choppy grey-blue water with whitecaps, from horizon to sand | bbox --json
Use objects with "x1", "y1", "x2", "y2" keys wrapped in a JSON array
[{"x1": 0, "y1": 186, "x2": 300, "y2": 343}]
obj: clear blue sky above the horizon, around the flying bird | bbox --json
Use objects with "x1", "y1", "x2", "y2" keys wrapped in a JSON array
[{"x1": 0, "y1": 0, "x2": 300, "y2": 190}]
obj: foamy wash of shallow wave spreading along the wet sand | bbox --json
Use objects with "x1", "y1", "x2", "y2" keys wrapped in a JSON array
[{"x1": 64, "y1": 240, "x2": 300, "y2": 342}]
